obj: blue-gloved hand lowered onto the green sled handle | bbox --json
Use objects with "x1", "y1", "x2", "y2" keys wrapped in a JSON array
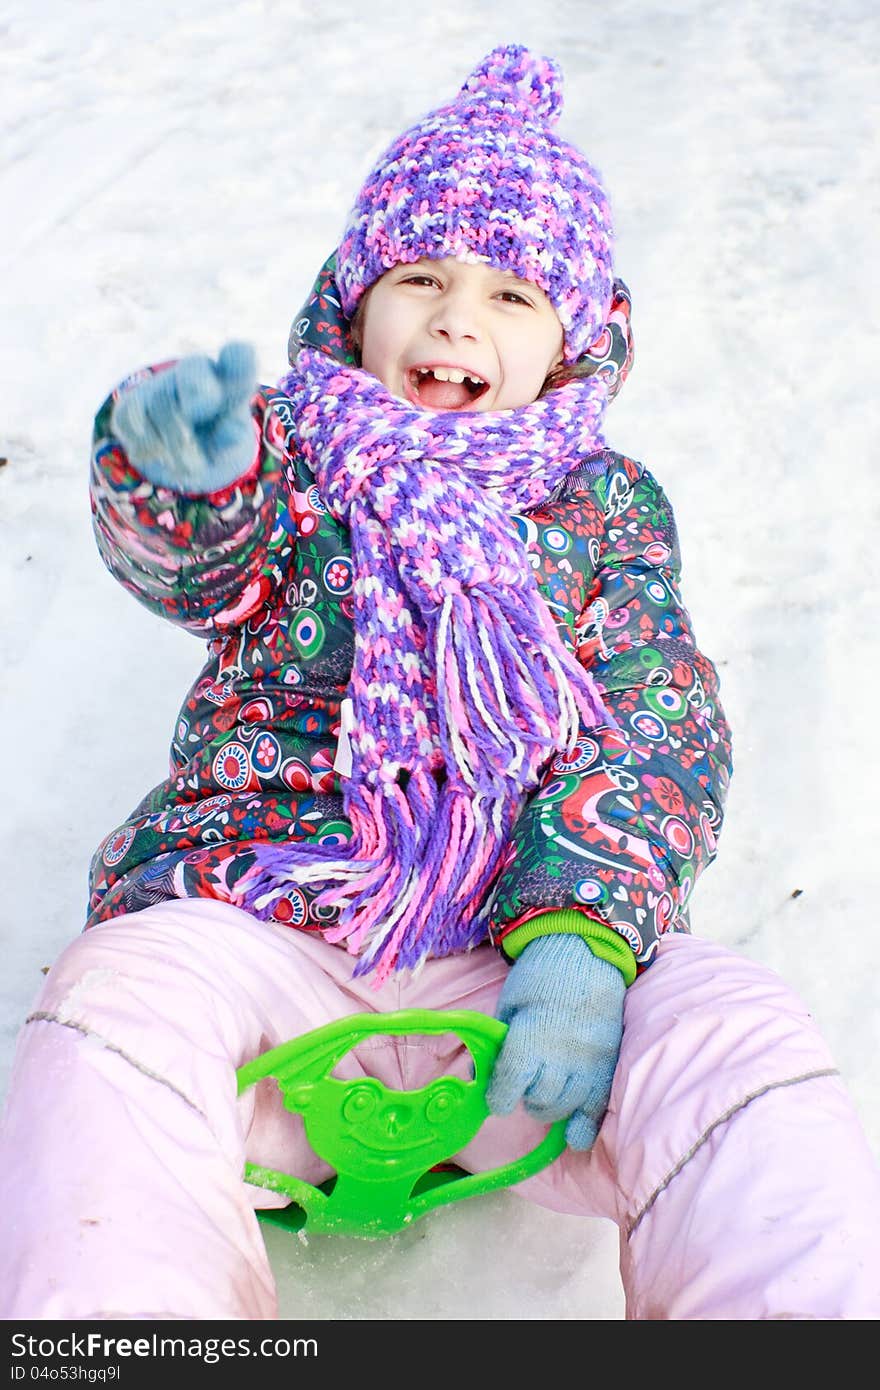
[{"x1": 487, "y1": 933, "x2": 627, "y2": 1150}]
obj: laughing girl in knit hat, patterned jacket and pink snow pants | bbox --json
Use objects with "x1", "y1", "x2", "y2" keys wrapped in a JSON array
[{"x1": 1, "y1": 46, "x2": 880, "y2": 1319}]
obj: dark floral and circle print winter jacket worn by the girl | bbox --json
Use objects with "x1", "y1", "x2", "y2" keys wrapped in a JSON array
[{"x1": 86, "y1": 291, "x2": 730, "y2": 967}]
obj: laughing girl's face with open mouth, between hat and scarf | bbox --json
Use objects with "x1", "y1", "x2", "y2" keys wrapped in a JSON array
[{"x1": 360, "y1": 259, "x2": 563, "y2": 410}]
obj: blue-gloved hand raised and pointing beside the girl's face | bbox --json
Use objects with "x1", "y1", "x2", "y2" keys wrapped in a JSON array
[{"x1": 111, "y1": 343, "x2": 257, "y2": 495}]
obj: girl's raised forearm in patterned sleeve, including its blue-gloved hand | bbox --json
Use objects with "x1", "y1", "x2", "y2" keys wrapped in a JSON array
[{"x1": 90, "y1": 343, "x2": 279, "y2": 637}]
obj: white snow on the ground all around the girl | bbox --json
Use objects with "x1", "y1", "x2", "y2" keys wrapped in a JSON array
[{"x1": 0, "y1": 0, "x2": 880, "y2": 1319}]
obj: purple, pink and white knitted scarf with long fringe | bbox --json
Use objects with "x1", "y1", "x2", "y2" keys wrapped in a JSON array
[{"x1": 236, "y1": 349, "x2": 609, "y2": 984}]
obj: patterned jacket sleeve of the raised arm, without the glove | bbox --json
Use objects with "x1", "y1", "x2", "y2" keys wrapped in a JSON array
[{"x1": 90, "y1": 364, "x2": 282, "y2": 637}]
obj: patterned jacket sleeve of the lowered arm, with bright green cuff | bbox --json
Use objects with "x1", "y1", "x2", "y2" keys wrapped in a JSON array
[{"x1": 489, "y1": 453, "x2": 731, "y2": 967}]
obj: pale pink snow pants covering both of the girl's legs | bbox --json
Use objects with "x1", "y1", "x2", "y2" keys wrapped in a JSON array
[{"x1": 0, "y1": 901, "x2": 880, "y2": 1321}]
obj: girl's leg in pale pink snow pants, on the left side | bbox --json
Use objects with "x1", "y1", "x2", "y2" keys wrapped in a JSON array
[{"x1": 0, "y1": 901, "x2": 411, "y2": 1319}]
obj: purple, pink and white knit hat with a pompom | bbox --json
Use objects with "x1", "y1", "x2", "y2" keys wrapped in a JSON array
[{"x1": 336, "y1": 44, "x2": 612, "y2": 361}]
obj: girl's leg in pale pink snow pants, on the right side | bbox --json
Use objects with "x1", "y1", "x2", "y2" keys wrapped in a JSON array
[{"x1": 458, "y1": 935, "x2": 880, "y2": 1321}]
